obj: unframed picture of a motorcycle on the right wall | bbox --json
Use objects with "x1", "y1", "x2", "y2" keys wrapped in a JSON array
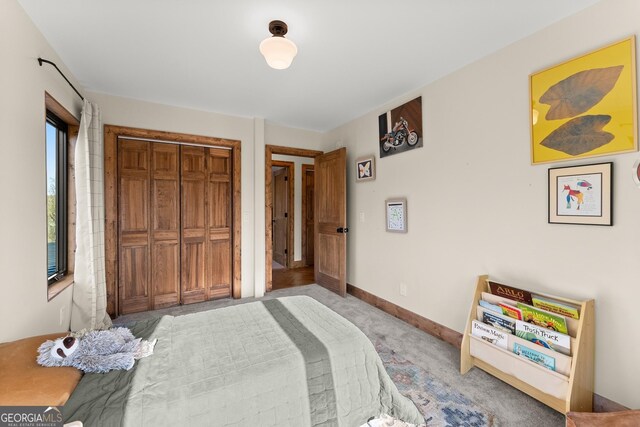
[{"x1": 378, "y1": 96, "x2": 422, "y2": 159}]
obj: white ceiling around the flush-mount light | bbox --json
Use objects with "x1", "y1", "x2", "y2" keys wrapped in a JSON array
[{"x1": 18, "y1": 0, "x2": 599, "y2": 131}]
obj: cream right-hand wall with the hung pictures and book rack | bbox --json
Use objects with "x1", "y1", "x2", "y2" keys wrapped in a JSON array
[{"x1": 325, "y1": 0, "x2": 640, "y2": 408}]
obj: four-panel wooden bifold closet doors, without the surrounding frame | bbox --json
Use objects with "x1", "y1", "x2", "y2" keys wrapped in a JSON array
[{"x1": 118, "y1": 139, "x2": 232, "y2": 314}]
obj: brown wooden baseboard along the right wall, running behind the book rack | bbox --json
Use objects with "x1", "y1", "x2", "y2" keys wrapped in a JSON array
[{"x1": 347, "y1": 283, "x2": 629, "y2": 412}]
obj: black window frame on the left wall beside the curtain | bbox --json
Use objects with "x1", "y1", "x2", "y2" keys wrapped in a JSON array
[{"x1": 45, "y1": 109, "x2": 69, "y2": 286}]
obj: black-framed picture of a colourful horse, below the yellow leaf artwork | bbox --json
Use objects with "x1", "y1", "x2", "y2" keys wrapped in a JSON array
[{"x1": 549, "y1": 162, "x2": 613, "y2": 225}]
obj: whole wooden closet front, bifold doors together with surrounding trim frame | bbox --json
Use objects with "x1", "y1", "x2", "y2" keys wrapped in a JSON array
[{"x1": 104, "y1": 125, "x2": 242, "y2": 316}]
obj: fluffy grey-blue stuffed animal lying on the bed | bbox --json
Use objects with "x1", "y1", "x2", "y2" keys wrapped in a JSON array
[{"x1": 37, "y1": 328, "x2": 157, "y2": 373}]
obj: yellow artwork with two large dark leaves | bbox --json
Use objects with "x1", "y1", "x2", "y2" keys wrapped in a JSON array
[{"x1": 529, "y1": 36, "x2": 638, "y2": 164}]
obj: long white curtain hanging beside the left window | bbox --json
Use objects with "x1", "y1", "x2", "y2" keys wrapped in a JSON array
[{"x1": 71, "y1": 100, "x2": 111, "y2": 331}]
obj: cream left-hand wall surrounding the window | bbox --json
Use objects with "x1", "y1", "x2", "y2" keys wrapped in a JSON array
[{"x1": 0, "y1": 0, "x2": 82, "y2": 342}]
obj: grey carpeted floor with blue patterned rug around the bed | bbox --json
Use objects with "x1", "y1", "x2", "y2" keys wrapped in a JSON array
[{"x1": 114, "y1": 285, "x2": 565, "y2": 427}]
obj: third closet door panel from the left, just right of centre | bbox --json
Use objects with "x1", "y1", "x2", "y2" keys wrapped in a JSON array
[{"x1": 180, "y1": 146, "x2": 208, "y2": 304}]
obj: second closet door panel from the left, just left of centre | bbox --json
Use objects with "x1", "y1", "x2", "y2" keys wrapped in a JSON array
[{"x1": 150, "y1": 143, "x2": 180, "y2": 310}]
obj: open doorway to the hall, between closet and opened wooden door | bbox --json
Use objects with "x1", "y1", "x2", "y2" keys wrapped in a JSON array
[{"x1": 265, "y1": 145, "x2": 322, "y2": 291}]
